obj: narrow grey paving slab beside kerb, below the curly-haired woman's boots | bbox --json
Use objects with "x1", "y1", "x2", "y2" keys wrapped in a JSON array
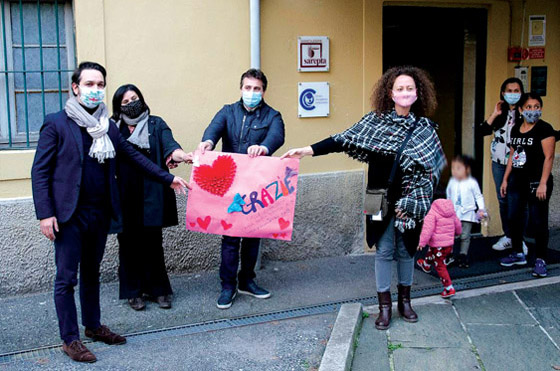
[{"x1": 352, "y1": 316, "x2": 390, "y2": 371}]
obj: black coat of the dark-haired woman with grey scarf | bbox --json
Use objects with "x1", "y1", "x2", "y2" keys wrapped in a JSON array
[{"x1": 117, "y1": 115, "x2": 181, "y2": 228}]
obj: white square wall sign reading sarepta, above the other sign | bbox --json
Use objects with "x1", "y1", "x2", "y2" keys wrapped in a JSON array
[{"x1": 298, "y1": 36, "x2": 329, "y2": 72}]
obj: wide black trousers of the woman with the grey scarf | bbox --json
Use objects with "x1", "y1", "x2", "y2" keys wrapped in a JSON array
[{"x1": 117, "y1": 226, "x2": 173, "y2": 299}]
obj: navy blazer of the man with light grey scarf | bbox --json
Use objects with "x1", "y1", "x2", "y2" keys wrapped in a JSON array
[{"x1": 31, "y1": 110, "x2": 173, "y2": 223}]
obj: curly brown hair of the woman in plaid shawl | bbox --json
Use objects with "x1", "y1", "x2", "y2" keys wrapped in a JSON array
[{"x1": 371, "y1": 66, "x2": 437, "y2": 117}]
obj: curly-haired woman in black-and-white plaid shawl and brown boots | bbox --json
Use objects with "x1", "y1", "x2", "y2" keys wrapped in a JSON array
[{"x1": 282, "y1": 66, "x2": 445, "y2": 330}]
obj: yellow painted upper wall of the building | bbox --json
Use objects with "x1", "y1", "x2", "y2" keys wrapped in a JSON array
[{"x1": 0, "y1": 0, "x2": 560, "y2": 235}]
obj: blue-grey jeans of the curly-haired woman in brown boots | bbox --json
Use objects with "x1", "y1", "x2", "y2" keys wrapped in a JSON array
[{"x1": 375, "y1": 218, "x2": 414, "y2": 292}]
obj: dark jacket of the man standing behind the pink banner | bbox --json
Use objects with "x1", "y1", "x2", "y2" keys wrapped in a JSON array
[{"x1": 202, "y1": 100, "x2": 284, "y2": 156}]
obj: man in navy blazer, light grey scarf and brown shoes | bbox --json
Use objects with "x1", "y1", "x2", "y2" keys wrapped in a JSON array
[{"x1": 31, "y1": 62, "x2": 187, "y2": 362}]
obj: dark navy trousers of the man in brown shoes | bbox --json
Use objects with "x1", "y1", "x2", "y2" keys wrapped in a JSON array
[{"x1": 54, "y1": 206, "x2": 110, "y2": 344}]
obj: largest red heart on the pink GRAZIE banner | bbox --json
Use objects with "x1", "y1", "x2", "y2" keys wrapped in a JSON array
[{"x1": 193, "y1": 156, "x2": 237, "y2": 197}]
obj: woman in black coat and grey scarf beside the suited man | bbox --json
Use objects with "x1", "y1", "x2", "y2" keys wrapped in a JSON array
[{"x1": 112, "y1": 84, "x2": 192, "y2": 310}]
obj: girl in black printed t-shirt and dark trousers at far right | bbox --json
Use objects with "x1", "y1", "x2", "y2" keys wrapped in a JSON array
[{"x1": 500, "y1": 93, "x2": 556, "y2": 277}]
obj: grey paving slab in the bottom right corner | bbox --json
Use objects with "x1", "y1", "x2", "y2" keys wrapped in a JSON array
[{"x1": 467, "y1": 324, "x2": 560, "y2": 371}]
